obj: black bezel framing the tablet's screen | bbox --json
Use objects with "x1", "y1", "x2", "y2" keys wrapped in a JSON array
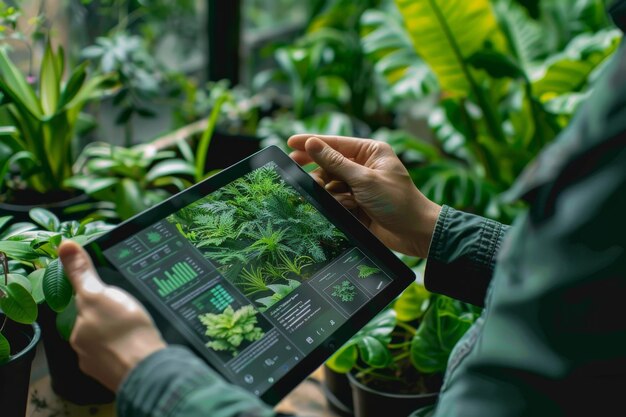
[{"x1": 86, "y1": 146, "x2": 415, "y2": 405}]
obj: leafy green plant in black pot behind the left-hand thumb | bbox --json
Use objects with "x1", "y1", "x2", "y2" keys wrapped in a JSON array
[{"x1": 0, "y1": 208, "x2": 114, "y2": 404}]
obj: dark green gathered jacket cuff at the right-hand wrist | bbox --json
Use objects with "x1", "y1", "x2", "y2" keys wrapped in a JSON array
[{"x1": 424, "y1": 206, "x2": 509, "y2": 307}]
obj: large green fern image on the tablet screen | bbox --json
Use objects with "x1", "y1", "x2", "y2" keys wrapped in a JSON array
[{"x1": 168, "y1": 163, "x2": 352, "y2": 311}]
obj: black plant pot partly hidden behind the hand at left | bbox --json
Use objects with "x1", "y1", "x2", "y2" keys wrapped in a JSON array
[{"x1": 38, "y1": 304, "x2": 115, "y2": 405}]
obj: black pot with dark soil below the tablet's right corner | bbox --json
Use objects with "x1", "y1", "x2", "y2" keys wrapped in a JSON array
[{"x1": 348, "y1": 361, "x2": 443, "y2": 417}]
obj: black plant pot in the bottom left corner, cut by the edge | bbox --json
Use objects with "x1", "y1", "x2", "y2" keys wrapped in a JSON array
[{"x1": 0, "y1": 318, "x2": 41, "y2": 417}]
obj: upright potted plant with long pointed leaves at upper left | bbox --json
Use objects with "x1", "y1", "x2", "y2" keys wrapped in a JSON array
[{"x1": 0, "y1": 42, "x2": 109, "y2": 220}]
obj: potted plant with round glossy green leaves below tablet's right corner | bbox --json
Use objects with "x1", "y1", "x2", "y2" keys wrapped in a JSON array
[{"x1": 326, "y1": 284, "x2": 479, "y2": 417}]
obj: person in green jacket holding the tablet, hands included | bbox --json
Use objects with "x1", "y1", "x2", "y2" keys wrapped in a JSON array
[{"x1": 59, "y1": 0, "x2": 626, "y2": 417}]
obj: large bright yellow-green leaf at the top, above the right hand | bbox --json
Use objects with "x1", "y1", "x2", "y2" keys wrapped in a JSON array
[{"x1": 395, "y1": 0, "x2": 498, "y2": 97}]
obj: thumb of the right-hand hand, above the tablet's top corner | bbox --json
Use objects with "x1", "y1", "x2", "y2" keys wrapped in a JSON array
[{"x1": 304, "y1": 137, "x2": 367, "y2": 185}]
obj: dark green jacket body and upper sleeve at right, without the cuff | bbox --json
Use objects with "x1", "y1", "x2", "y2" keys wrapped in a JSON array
[{"x1": 426, "y1": 39, "x2": 626, "y2": 417}]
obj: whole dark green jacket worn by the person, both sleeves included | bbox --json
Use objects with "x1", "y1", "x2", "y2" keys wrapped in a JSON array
[{"x1": 118, "y1": 0, "x2": 626, "y2": 417}]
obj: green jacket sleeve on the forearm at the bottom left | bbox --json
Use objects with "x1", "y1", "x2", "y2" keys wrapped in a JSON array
[{"x1": 117, "y1": 347, "x2": 286, "y2": 417}]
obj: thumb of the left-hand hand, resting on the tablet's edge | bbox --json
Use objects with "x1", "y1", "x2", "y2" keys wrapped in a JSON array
[{"x1": 59, "y1": 240, "x2": 106, "y2": 295}]
